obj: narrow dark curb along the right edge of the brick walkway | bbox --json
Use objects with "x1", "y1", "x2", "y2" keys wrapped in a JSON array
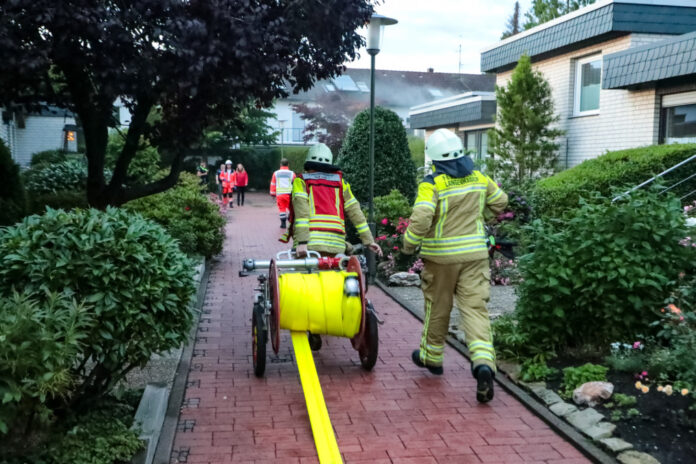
[{"x1": 375, "y1": 280, "x2": 618, "y2": 464}]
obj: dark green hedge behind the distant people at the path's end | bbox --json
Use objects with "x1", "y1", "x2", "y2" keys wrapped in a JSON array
[{"x1": 208, "y1": 145, "x2": 309, "y2": 192}]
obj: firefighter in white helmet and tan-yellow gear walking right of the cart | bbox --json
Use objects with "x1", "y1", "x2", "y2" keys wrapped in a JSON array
[{"x1": 403, "y1": 129, "x2": 507, "y2": 402}]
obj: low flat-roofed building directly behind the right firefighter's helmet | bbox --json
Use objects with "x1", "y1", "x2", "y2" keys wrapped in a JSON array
[{"x1": 409, "y1": 91, "x2": 496, "y2": 161}]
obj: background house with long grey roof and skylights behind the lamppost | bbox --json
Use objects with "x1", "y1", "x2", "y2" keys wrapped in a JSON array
[{"x1": 270, "y1": 68, "x2": 495, "y2": 144}]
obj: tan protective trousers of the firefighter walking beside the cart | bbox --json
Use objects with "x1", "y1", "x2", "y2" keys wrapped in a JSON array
[{"x1": 420, "y1": 259, "x2": 495, "y2": 372}]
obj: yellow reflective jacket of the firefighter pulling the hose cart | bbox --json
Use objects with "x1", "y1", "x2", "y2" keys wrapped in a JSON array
[{"x1": 292, "y1": 173, "x2": 374, "y2": 254}]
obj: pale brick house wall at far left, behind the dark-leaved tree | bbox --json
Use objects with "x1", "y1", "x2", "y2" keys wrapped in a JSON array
[{"x1": 0, "y1": 106, "x2": 78, "y2": 167}]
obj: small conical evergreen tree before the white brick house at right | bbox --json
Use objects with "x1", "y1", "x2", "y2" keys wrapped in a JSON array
[{"x1": 488, "y1": 55, "x2": 563, "y2": 185}]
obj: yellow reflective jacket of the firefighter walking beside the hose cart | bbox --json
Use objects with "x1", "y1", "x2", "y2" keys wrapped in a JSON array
[{"x1": 403, "y1": 161, "x2": 508, "y2": 264}]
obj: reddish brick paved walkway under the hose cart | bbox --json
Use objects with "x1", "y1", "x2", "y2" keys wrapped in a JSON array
[{"x1": 171, "y1": 195, "x2": 588, "y2": 464}]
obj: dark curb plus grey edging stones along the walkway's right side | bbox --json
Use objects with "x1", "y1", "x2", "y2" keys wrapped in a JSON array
[{"x1": 375, "y1": 280, "x2": 616, "y2": 464}]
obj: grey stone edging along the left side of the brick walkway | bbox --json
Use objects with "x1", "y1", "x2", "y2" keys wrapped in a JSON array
[{"x1": 131, "y1": 257, "x2": 209, "y2": 464}]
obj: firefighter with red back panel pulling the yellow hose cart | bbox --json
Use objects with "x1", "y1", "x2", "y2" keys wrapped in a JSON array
[{"x1": 281, "y1": 143, "x2": 382, "y2": 351}]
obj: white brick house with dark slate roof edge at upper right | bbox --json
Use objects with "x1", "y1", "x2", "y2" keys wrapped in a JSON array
[{"x1": 481, "y1": 0, "x2": 696, "y2": 167}]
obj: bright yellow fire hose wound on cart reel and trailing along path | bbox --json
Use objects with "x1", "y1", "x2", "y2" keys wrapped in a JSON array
[{"x1": 278, "y1": 271, "x2": 362, "y2": 464}]
